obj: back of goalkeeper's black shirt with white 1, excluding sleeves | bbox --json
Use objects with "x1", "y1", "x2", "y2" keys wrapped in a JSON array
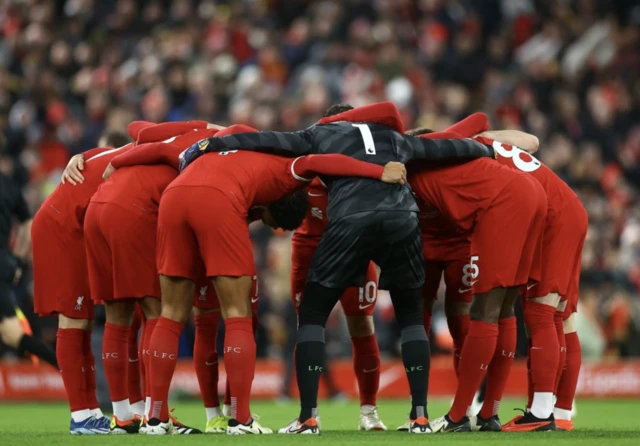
[{"x1": 313, "y1": 121, "x2": 418, "y2": 220}]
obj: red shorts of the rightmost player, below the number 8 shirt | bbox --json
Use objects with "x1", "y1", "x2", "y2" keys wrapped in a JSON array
[{"x1": 527, "y1": 198, "x2": 589, "y2": 301}]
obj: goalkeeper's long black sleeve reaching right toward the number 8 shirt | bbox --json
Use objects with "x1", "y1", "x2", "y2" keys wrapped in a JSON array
[{"x1": 404, "y1": 136, "x2": 495, "y2": 161}]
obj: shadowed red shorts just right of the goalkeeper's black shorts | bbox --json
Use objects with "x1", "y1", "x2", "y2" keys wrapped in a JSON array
[{"x1": 422, "y1": 234, "x2": 473, "y2": 302}]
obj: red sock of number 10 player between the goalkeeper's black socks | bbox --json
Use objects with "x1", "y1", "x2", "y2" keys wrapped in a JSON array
[{"x1": 351, "y1": 334, "x2": 380, "y2": 406}]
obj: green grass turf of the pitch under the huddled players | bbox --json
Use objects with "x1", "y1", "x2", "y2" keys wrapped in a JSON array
[{"x1": 0, "y1": 400, "x2": 640, "y2": 446}]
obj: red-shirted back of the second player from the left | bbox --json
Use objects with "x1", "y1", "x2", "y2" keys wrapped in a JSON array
[{"x1": 91, "y1": 165, "x2": 178, "y2": 217}]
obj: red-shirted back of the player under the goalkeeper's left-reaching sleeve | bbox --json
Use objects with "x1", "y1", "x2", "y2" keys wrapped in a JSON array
[{"x1": 168, "y1": 150, "x2": 302, "y2": 212}]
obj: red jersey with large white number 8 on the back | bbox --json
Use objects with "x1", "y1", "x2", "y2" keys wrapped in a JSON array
[{"x1": 476, "y1": 137, "x2": 578, "y2": 212}]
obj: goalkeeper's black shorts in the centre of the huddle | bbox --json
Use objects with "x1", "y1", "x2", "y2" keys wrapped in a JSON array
[{"x1": 307, "y1": 211, "x2": 424, "y2": 289}]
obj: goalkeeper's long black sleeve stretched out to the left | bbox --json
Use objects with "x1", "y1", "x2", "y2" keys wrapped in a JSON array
[{"x1": 205, "y1": 127, "x2": 313, "y2": 156}]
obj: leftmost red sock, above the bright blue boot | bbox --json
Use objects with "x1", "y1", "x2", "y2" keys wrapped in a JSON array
[{"x1": 56, "y1": 328, "x2": 87, "y2": 412}]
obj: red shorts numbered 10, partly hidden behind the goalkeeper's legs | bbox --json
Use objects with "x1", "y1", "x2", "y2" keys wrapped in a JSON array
[{"x1": 291, "y1": 242, "x2": 378, "y2": 316}]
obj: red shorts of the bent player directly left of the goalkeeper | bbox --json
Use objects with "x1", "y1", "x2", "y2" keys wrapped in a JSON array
[{"x1": 157, "y1": 186, "x2": 256, "y2": 282}]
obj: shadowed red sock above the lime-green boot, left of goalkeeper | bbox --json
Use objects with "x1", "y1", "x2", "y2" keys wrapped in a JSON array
[{"x1": 193, "y1": 312, "x2": 220, "y2": 407}]
